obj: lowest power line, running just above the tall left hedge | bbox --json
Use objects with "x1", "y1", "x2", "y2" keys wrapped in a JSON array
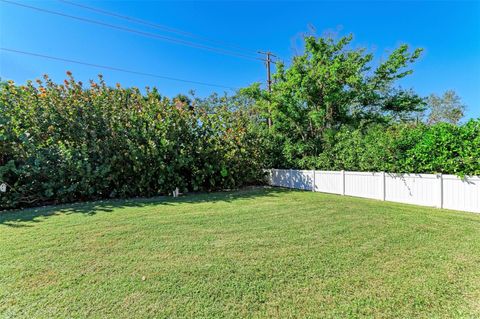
[{"x1": 0, "y1": 48, "x2": 236, "y2": 90}]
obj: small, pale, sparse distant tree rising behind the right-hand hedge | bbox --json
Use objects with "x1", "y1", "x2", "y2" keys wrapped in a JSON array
[{"x1": 427, "y1": 90, "x2": 466, "y2": 125}]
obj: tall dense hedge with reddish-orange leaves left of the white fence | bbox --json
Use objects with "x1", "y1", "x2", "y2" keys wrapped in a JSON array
[{"x1": 0, "y1": 74, "x2": 263, "y2": 208}]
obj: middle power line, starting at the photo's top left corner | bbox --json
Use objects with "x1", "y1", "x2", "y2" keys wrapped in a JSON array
[{"x1": 0, "y1": 0, "x2": 263, "y2": 61}]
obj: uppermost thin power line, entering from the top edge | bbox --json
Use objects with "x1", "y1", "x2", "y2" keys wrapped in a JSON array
[{"x1": 57, "y1": 0, "x2": 255, "y2": 54}]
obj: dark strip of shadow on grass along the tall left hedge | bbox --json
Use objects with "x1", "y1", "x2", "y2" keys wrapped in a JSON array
[{"x1": 0, "y1": 187, "x2": 288, "y2": 227}]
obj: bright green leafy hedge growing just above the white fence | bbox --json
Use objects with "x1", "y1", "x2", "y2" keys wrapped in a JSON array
[{"x1": 293, "y1": 120, "x2": 480, "y2": 176}]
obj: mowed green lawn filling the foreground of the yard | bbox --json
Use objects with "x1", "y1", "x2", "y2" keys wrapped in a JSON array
[{"x1": 0, "y1": 189, "x2": 480, "y2": 318}]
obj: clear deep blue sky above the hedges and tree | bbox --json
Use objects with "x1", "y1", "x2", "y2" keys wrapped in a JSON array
[{"x1": 0, "y1": 0, "x2": 480, "y2": 118}]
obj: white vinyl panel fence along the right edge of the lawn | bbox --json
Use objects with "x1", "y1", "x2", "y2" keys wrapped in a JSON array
[{"x1": 267, "y1": 169, "x2": 480, "y2": 213}]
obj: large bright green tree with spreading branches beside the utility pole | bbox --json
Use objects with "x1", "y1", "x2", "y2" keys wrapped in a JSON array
[{"x1": 248, "y1": 35, "x2": 424, "y2": 165}]
